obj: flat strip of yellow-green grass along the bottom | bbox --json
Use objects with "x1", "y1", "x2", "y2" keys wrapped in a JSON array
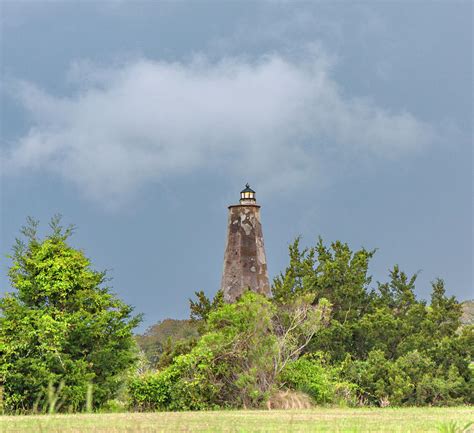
[{"x1": 0, "y1": 406, "x2": 474, "y2": 433}]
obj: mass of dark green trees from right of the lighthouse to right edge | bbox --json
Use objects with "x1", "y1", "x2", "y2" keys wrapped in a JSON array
[{"x1": 273, "y1": 239, "x2": 474, "y2": 406}]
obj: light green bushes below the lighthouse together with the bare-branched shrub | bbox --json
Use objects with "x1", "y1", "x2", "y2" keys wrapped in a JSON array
[{"x1": 130, "y1": 292, "x2": 329, "y2": 410}]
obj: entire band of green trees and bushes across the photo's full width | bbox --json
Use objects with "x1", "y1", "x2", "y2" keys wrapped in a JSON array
[{"x1": 0, "y1": 218, "x2": 474, "y2": 413}]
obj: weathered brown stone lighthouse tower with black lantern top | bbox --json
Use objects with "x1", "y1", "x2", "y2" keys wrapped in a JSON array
[{"x1": 221, "y1": 184, "x2": 270, "y2": 302}]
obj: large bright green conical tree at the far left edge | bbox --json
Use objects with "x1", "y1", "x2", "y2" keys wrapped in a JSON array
[{"x1": 0, "y1": 216, "x2": 140, "y2": 411}]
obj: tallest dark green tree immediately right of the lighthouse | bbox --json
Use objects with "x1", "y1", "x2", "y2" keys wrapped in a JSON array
[{"x1": 273, "y1": 238, "x2": 375, "y2": 361}]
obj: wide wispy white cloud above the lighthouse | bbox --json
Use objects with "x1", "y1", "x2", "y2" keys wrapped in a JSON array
[{"x1": 2, "y1": 50, "x2": 434, "y2": 202}]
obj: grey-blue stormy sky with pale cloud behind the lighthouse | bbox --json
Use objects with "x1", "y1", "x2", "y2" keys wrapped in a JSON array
[{"x1": 0, "y1": 0, "x2": 474, "y2": 330}]
